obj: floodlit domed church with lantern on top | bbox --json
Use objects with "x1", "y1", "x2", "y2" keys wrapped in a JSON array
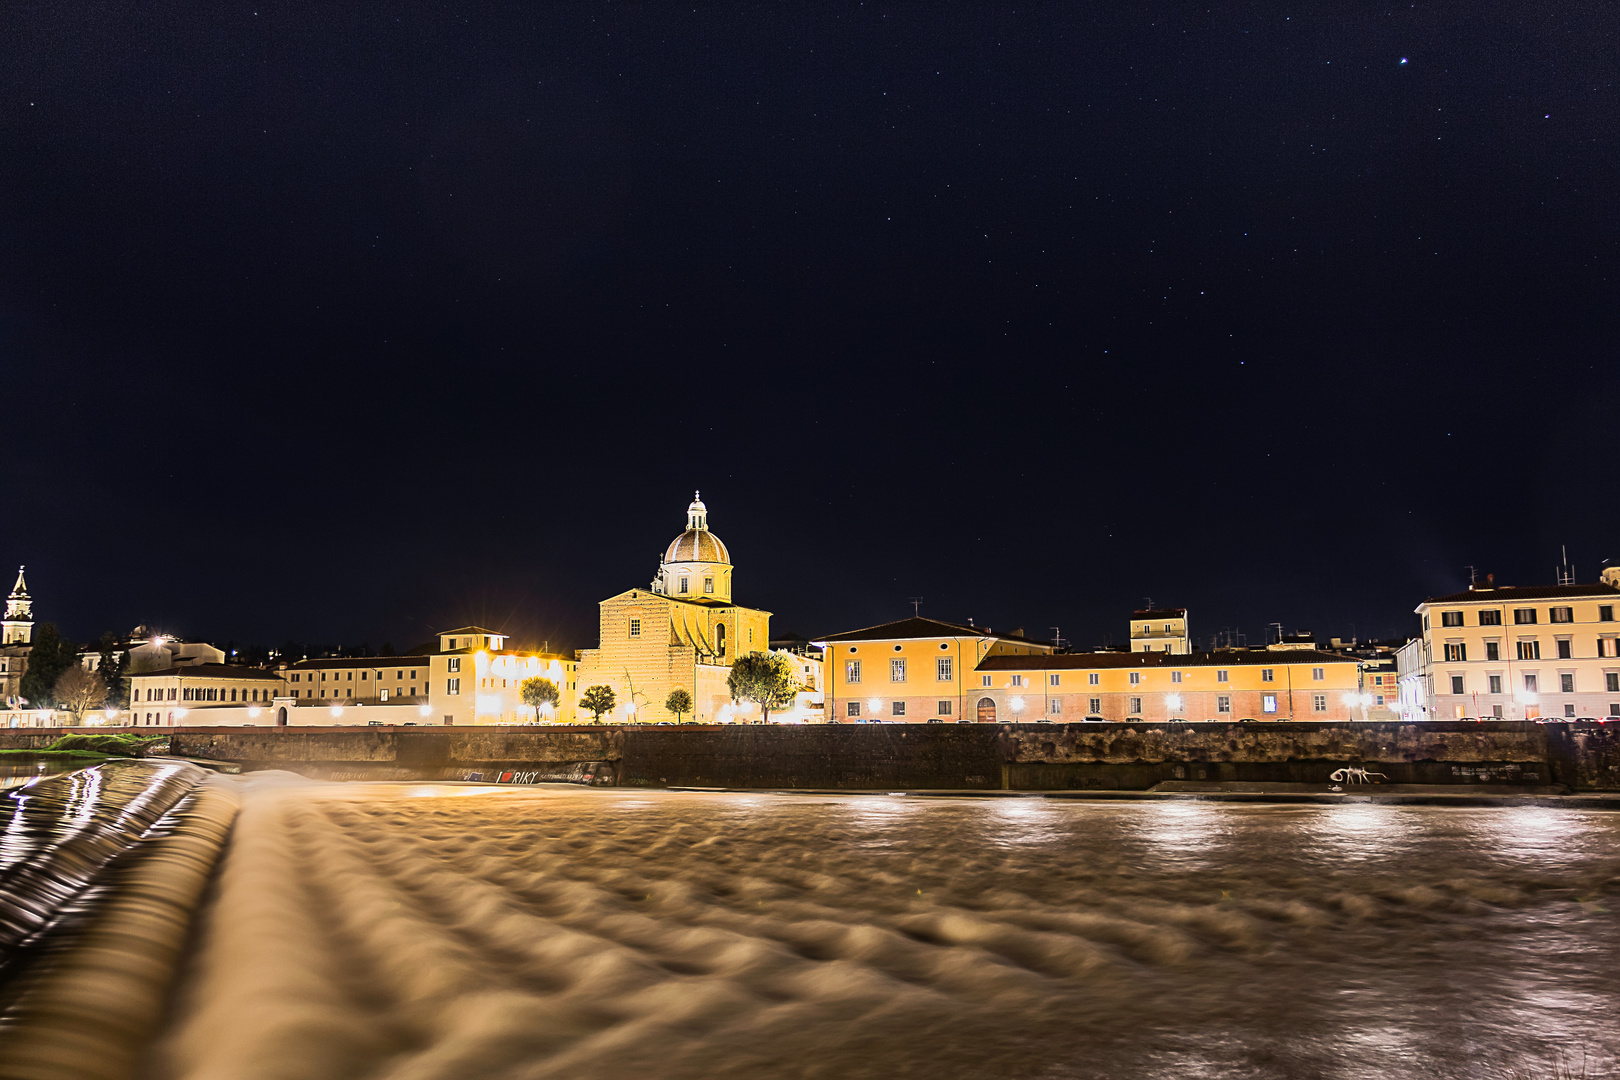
[{"x1": 575, "y1": 495, "x2": 771, "y2": 724}]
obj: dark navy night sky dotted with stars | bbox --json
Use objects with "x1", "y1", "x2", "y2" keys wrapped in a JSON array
[{"x1": 0, "y1": 0, "x2": 1620, "y2": 649}]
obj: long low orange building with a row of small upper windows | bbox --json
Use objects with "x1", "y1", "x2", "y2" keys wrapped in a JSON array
[{"x1": 974, "y1": 649, "x2": 1361, "y2": 724}]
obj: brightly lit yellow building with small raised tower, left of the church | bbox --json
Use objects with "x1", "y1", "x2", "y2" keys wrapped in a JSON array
[{"x1": 428, "y1": 627, "x2": 578, "y2": 724}]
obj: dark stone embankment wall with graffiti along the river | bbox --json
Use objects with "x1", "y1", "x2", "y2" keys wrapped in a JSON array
[{"x1": 161, "y1": 721, "x2": 1620, "y2": 790}]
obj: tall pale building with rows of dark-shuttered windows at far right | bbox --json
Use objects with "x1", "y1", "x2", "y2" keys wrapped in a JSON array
[{"x1": 1411, "y1": 581, "x2": 1620, "y2": 721}]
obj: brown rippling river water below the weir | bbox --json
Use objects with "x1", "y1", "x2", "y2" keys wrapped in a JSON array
[{"x1": 151, "y1": 777, "x2": 1620, "y2": 1080}]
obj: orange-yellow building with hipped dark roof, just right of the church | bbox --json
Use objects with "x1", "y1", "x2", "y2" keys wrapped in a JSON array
[{"x1": 815, "y1": 617, "x2": 1051, "y2": 724}]
